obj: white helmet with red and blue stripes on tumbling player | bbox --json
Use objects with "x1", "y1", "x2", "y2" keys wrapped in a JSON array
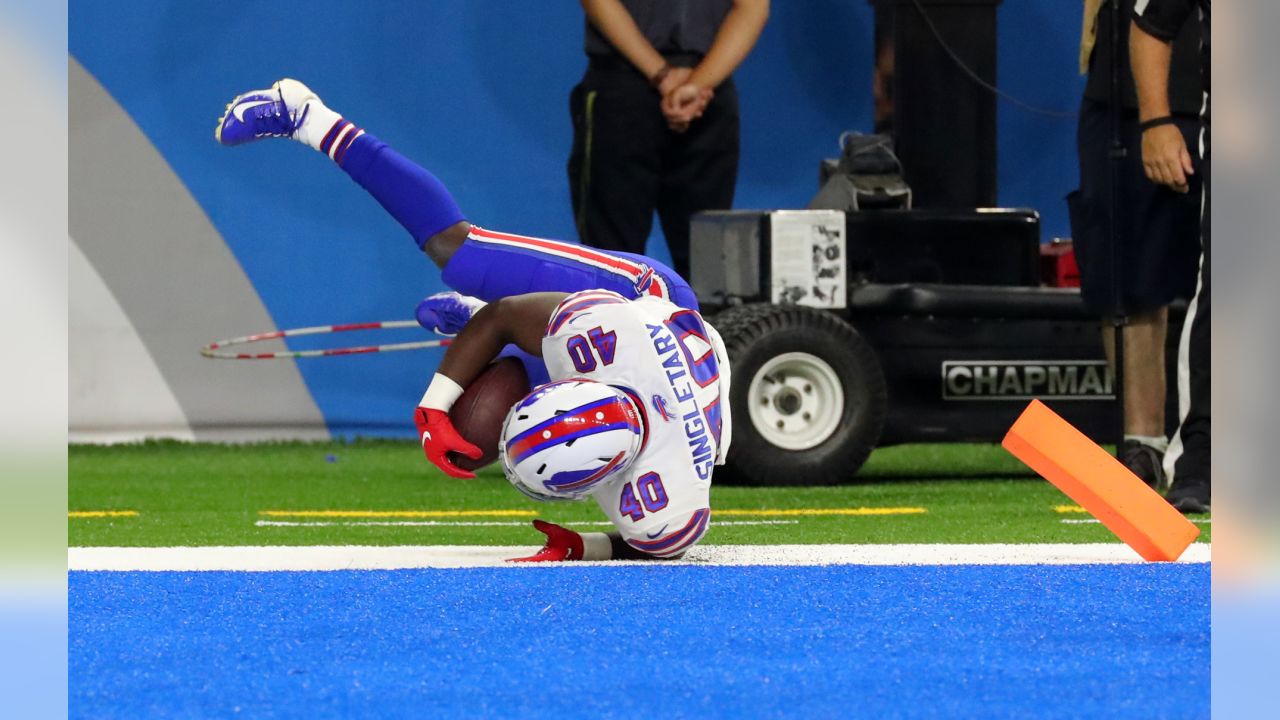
[{"x1": 502, "y1": 379, "x2": 645, "y2": 500}]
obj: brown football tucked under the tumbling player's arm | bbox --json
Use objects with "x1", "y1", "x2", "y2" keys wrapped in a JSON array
[{"x1": 449, "y1": 357, "x2": 529, "y2": 470}]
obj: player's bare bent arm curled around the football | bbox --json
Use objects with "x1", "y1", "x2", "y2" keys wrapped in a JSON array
[{"x1": 436, "y1": 292, "x2": 568, "y2": 387}]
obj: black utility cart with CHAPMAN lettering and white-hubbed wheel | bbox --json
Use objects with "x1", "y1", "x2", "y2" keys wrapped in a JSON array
[{"x1": 691, "y1": 209, "x2": 1176, "y2": 486}]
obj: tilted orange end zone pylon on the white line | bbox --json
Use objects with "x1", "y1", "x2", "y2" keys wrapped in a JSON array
[{"x1": 1001, "y1": 400, "x2": 1199, "y2": 561}]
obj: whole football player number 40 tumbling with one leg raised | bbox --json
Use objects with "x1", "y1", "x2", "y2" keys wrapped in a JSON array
[{"x1": 215, "y1": 79, "x2": 731, "y2": 561}]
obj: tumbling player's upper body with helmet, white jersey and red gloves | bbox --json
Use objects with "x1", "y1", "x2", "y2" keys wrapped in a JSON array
[{"x1": 417, "y1": 290, "x2": 731, "y2": 560}]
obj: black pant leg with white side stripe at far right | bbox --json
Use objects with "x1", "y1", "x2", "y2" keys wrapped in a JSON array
[{"x1": 1174, "y1": 129, "x2": 1211, "y2": 487}]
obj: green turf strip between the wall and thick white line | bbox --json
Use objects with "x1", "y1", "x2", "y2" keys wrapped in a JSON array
[{"x1": 68, "y1": 441, "x2": 1210, "y2": 546}]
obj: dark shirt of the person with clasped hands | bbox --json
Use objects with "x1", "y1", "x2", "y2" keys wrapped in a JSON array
[{"x1": 586, "y1": 0, "x2": 733, "y2": 56}]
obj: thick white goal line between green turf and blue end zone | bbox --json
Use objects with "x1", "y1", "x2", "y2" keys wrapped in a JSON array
[{"x1": 67, "y1": 543, "x2": 1210, "y2": 571}]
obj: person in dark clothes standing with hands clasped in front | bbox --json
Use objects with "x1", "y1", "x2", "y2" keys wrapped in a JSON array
[{"x1": 568, "y1": 0, "x2": 769, "y2": 277}]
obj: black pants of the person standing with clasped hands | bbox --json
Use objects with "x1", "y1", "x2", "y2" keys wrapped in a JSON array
[{"x1": 568, "y1": 65, "x2": 739, "y2": 278}]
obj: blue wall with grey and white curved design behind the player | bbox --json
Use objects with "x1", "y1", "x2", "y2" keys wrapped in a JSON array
[{"x1": 69, "y1": 0, "x2": 1082, "y2": 439}]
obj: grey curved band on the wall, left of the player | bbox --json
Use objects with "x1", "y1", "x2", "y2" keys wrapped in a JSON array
[{"x1": 68, "y1": 58, "x2": 329, "y2": 439}]
